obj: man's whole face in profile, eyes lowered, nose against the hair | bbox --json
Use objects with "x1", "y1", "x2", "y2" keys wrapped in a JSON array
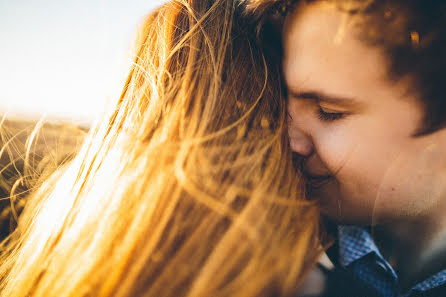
[{"x1": 283, "y1": 2, "x2": 446, "y2": 224}]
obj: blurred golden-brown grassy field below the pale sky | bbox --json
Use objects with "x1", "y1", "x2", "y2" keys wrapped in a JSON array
[{"x1": 0, "y1": 117, "x2": 85, "y2": 241}]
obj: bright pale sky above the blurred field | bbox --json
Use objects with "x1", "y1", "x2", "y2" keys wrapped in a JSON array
[{"x1": 0, "y1": 0, "x2": 165, "y2": 122}]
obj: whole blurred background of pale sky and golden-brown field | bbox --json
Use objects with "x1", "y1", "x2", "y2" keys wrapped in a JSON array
[{"x1": 0, "y1": 0, "x2": 164, "y2": 239}]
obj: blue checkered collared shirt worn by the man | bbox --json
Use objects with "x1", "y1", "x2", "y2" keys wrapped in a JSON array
[{"x1": 338, "y1": 226, "x2": 446, "y2": 297}]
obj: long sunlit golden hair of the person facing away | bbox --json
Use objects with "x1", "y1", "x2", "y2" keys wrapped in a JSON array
[{"x1": 0, "y1": 0, "x2": 320, "y2": 297}]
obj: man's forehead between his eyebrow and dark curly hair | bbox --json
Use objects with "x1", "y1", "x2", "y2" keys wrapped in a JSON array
[{"x1": 283, "y1": 3, "x2": 398, "y2": 104}]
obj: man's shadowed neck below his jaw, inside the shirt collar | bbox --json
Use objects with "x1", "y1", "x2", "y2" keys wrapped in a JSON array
[{"x1": 372, "y1": 215, "x2": 446, "y2": 289}]
